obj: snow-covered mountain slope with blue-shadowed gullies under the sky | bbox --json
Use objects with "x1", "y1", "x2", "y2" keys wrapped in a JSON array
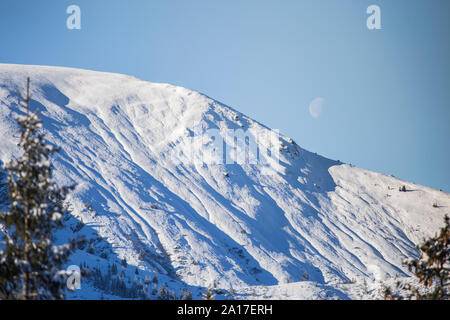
[{"x1": 0, "y1": 64, "x2": 450, "y2": 298}]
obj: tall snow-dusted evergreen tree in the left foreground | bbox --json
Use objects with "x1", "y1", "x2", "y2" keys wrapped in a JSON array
[{"x1": 0, "y1": 78, "x2": 73, "y2": 300}]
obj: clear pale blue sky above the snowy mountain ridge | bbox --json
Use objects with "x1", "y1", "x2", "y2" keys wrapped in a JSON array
[{"x1": 0, "y1": 0, "x2": 450, "y2": 192}]
